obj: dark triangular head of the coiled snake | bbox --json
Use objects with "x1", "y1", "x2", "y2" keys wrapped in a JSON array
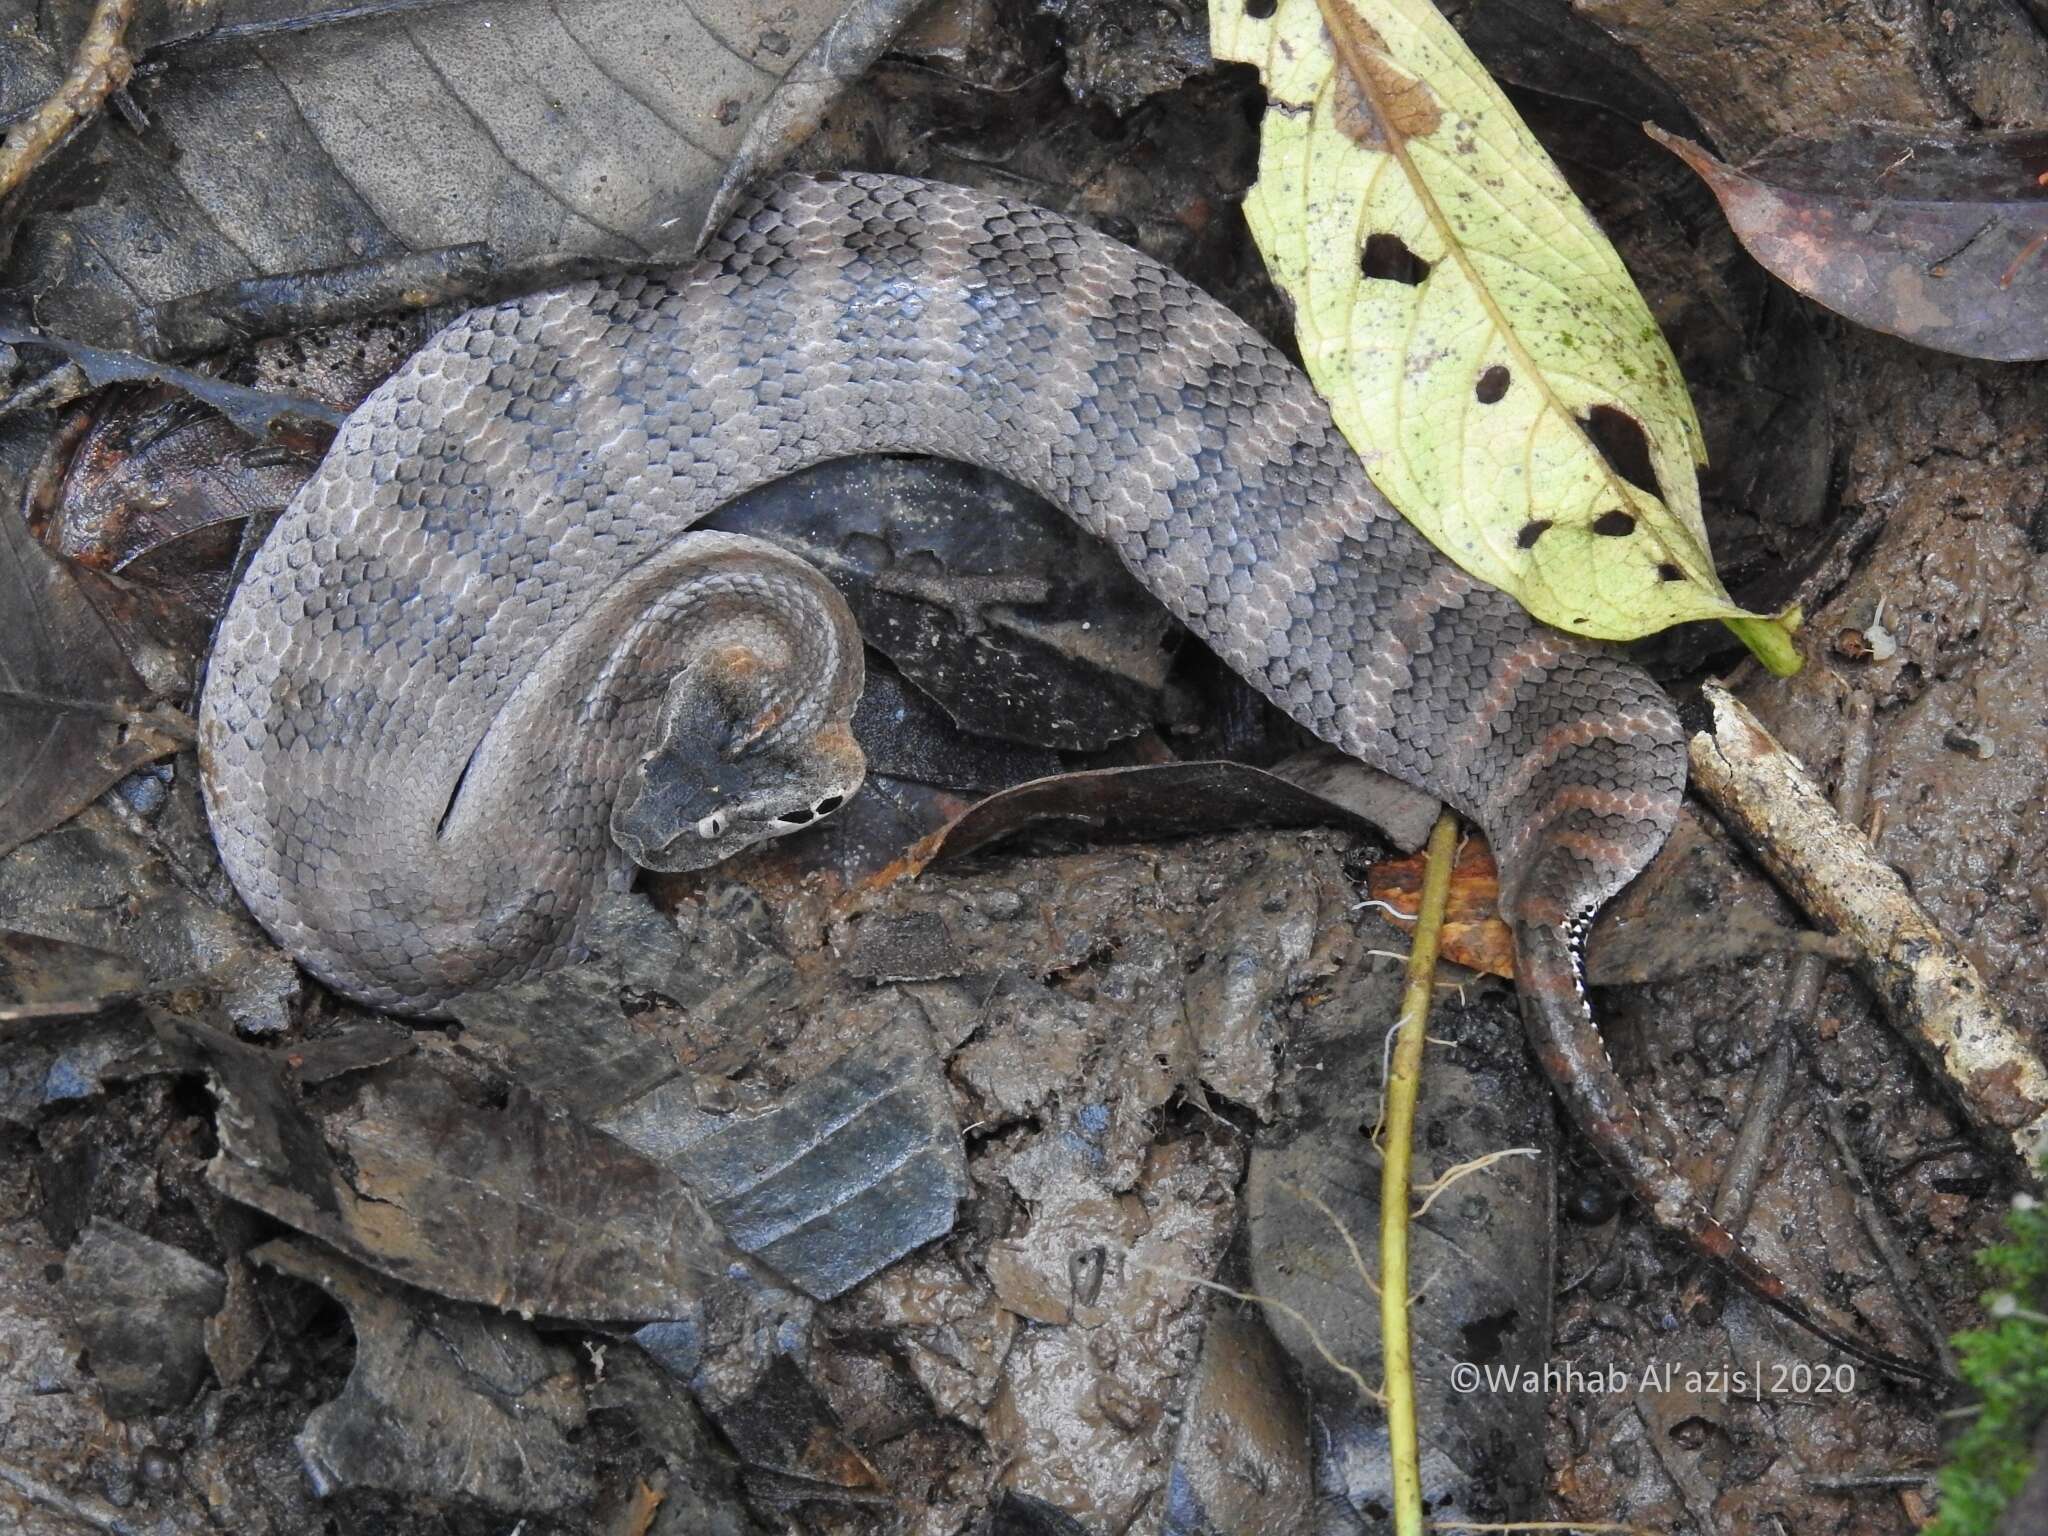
[{"x1": 612, "y1": 643, "x2": 866, "y2": 872}]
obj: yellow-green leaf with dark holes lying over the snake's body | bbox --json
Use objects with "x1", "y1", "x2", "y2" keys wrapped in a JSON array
[{"x1": 1208, "y1": 0, "x2": 1798, "y2": 672}]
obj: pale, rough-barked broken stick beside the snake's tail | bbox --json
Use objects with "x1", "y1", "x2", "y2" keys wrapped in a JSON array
[{"x1": 1690, "y1": 684, "x2": 2048, "y2": 1169}]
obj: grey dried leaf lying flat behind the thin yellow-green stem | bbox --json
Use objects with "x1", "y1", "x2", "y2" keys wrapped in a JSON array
[{"x1": 1245, "y1": 954, "x2": 1554, "y2": 1520}]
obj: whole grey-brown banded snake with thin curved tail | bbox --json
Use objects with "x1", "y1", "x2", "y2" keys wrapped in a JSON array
[{"x1": 199, "y1": 174, "x2": 1923, "y2": 1374}]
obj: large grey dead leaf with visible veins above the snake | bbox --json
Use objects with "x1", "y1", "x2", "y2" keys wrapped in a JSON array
[{"x1": 0, "y1": 0, "x2": 909, "y2": 346}]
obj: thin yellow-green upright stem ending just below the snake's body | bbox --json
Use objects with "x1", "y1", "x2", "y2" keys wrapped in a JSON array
[{"x1": 1380, "y1": 811, "x2": 1458, "y2": 1536}]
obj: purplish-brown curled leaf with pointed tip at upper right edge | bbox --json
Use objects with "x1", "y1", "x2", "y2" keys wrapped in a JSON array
[{"x1": 1645, "y1": 123, "x2": 2048, "y2": 362}]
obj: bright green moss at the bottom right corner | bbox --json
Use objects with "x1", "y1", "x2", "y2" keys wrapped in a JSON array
[{"x1": 1923, "y1": 1196, "x2": 2048, "y2": 1536}]
